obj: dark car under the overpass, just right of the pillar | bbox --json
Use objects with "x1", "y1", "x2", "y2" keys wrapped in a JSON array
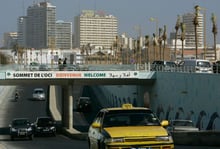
[{"x1": 77, "y1": 97, "x2": 91, "y2": 112}]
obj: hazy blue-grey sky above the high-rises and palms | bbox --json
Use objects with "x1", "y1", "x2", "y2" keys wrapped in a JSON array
[{"x1": 0, "y1": 0, "x2": 220, "y2": 46}]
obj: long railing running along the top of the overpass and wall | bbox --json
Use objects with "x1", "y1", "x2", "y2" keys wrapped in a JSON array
[{"x1": 0, "y1": 63, "x2": 220, "y2": 73}]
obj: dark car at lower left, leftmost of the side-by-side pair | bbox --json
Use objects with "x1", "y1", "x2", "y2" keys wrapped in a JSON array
[{"x1": 9, "y1": 118, "x2": 33, "y2": 140}]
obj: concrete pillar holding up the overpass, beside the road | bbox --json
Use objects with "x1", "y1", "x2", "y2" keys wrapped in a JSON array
[{"x1": 62, "y1": 84, "x2": 73, "y2": 129}]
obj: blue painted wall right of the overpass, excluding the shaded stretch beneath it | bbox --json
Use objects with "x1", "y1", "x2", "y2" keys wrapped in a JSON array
[{"x1": 150, "y1": 72, "x2": 220, "y2": 130}]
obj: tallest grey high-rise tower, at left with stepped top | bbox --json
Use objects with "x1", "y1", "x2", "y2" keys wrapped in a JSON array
[{"x1": 27, "y1": 2, "x2": 56, "y2": 49}]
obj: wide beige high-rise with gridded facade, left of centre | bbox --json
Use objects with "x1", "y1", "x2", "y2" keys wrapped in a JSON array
[{"x1": 74, "y1": 10, "x2": 118, "y2": 49}]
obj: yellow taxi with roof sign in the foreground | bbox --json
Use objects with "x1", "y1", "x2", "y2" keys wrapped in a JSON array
[{"x1": 88, "y1": 104, "x2": 174, "y2": 149}]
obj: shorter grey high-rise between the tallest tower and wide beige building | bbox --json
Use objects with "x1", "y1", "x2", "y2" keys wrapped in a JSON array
[{"x1": 56, "y1": 21, "x2": 72, "y2": 49}]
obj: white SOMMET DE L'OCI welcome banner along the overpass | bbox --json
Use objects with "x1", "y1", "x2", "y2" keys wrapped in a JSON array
[{"x1": 5, "y1": 71, "x2": 139, "y2": 79}]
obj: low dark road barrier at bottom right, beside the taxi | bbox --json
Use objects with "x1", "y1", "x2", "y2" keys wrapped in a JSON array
[{"x1": 172, "y1": 131, "x2": 220, "y2": 146}]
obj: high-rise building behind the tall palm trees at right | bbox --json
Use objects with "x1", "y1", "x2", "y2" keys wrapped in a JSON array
[{"x1": 182, "y1": 13, "x2": 204, "y2": 48}]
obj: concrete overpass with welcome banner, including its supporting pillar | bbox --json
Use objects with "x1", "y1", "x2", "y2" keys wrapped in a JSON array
[{"x1": 0, "y1": 71, "x2": 156, "y2": 129}]
